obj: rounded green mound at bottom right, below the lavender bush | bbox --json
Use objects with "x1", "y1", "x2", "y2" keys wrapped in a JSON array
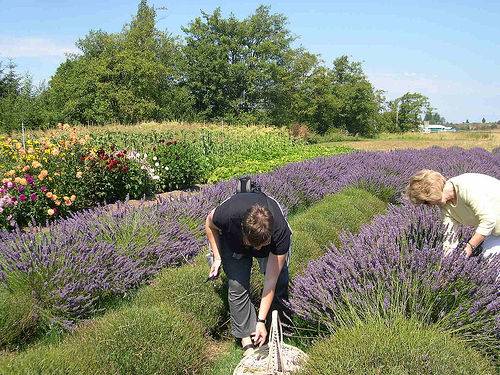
[{"x1": 302, "y1": 318, "x2": 495, "y2": 375}]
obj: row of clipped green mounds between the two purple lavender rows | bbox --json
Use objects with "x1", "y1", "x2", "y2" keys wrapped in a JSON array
[{"x1": 0, "y1": 189, "x2": 385, "y2": 374}]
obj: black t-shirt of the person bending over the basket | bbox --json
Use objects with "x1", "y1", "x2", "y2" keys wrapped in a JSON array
[{"x1": 213, "y1": 192, "x2": 292, "y2": 258}]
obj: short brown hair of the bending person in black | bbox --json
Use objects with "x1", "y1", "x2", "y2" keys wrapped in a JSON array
[{"x1": 242, "y1": 204, "x2": 274, "y2": 247}]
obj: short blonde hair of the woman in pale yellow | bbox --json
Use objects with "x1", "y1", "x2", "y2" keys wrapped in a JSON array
[{"x1": 406, "y1": 169, "x2": 446, "y2": 204}]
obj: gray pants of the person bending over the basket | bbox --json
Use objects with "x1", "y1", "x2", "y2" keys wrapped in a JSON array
[{"x1": 221, "y1": 250, "x2": 290, "y2": 338}]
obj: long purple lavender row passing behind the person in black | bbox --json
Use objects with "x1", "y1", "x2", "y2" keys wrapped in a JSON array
[{"x1": 0, "y1": 148, "x2": 500, "y2": 344}]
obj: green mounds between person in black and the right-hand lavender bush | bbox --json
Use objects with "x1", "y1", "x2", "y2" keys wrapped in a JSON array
[{"x1": 290, "y1": 188, "x2": 387, "y2": 275}]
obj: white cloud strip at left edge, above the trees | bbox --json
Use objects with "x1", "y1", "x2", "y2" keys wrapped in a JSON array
[{"x1": 0, "y1": 36, "x2": 78, "y2": 59}]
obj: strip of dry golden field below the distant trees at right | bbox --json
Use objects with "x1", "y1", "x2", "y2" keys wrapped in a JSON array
[{"x1": 340, "y1": 130, "x2": 500, "y2": 151}]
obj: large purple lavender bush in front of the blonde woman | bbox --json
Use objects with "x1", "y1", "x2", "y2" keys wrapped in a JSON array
[{"x1": 291, "y1": 204, "x2": 500, "y2": 353}]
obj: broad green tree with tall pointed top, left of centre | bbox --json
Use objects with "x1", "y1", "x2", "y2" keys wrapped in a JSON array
[{"x1": 45, "y1": 0, "x2": 191, "y2": 124}]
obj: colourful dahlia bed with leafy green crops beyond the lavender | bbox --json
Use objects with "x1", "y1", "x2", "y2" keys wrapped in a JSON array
[{"x1": 0, "y1": 123, "x2": 348, "y2": 229}]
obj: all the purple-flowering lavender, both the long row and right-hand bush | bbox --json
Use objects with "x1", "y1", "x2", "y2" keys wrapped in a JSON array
[{"x1": 0, "y1": 148, "x2": 500, "y2": 373}]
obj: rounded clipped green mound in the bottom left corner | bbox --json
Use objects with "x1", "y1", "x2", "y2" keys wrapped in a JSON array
[{"x1": 0, "y1": 304, "x2": 206, "y2": 374}]
